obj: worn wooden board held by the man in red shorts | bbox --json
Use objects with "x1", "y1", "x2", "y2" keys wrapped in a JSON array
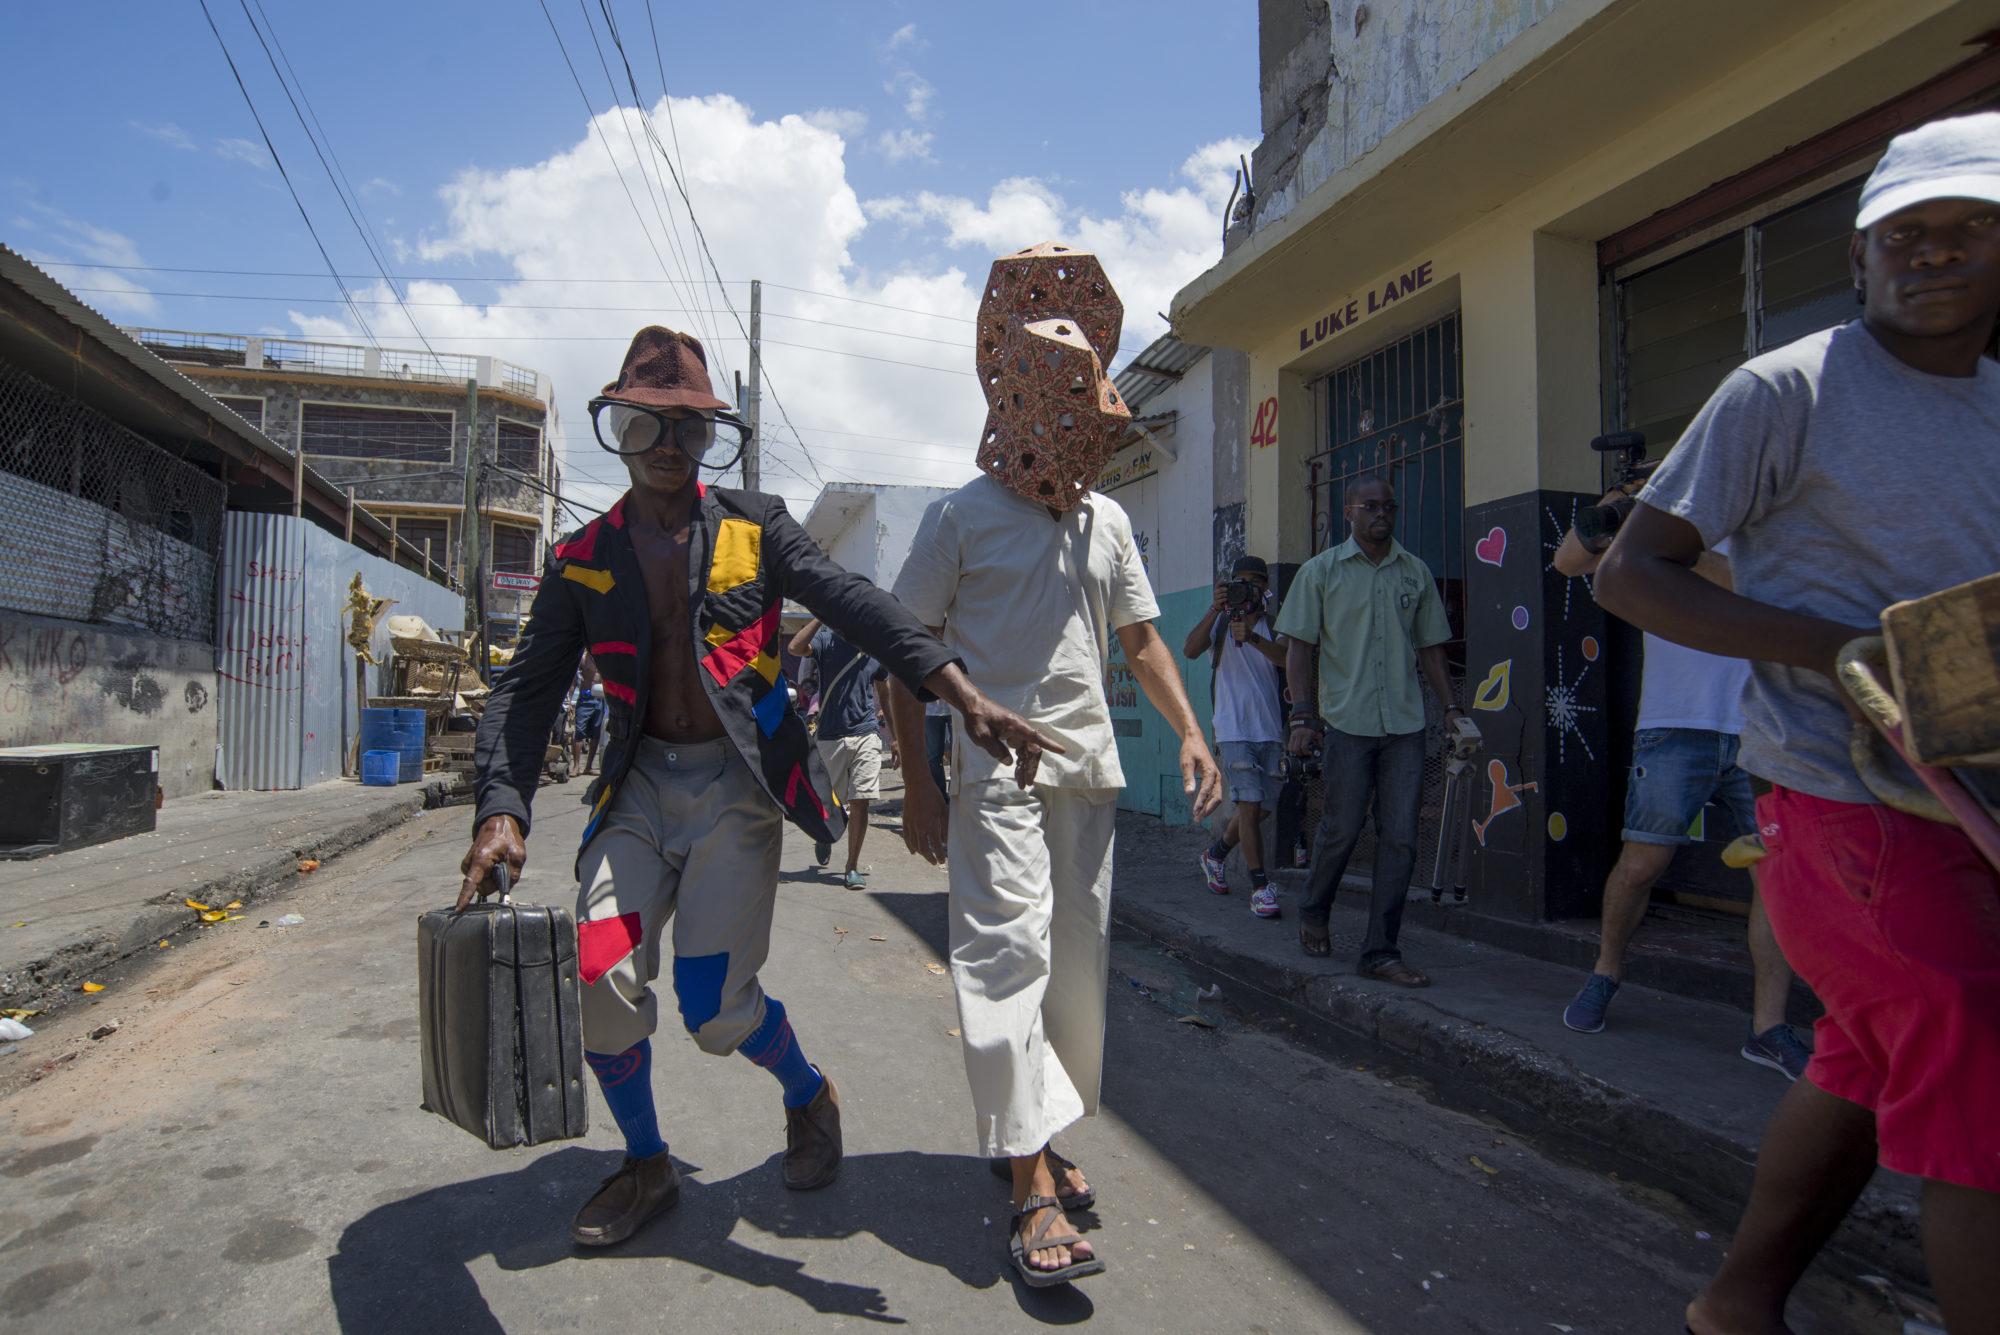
[{"x1": 1882, "y1": 574, "x2": 2000, "y2": 765}]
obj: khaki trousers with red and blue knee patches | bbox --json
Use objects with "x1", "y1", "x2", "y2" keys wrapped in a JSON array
[{"x1": 576, "y1": 737, "x2": 784, "y2": 1053}]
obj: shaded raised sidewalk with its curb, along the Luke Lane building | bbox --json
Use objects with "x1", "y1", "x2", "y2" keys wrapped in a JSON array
[{"x1": 1112, "y1": 811, "x2": 1924, "y2": 1279}]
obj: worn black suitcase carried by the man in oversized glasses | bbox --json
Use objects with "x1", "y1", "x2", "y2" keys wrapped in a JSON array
[{"x1": 416, "y1": 879, "x2": 590, "y2": 1149}]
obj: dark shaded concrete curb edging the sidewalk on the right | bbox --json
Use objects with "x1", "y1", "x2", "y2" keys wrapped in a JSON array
[{"x1": 1112, "y1": 895, "x2": 1928, "y2": 1285}]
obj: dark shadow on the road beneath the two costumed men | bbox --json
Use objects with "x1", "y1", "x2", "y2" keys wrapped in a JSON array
[{"x1": 326, "y1": 1143, "x2": 1092, "y2": 1335}]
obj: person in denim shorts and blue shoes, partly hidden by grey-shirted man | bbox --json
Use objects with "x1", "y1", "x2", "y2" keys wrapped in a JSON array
[{"x1": 1554, "y1": 519, "x2": 1812, "y2": 1079}]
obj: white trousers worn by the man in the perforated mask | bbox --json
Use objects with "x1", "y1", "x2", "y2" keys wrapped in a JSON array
[{"x1": 950, "y1": 777, "x2": 1118, "y2": 1159}]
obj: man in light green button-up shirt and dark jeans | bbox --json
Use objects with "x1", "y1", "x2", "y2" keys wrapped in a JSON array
[{"x1": 1276, "y1": 476, "x2": 1464, "y2": 987}]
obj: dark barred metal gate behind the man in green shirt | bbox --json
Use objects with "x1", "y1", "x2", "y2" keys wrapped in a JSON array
[{"x1": 1306, "y1": 312, "x2": 1466, "y2": 885}]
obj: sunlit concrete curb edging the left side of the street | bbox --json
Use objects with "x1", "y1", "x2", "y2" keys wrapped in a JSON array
[{"x1": 0, "y1": 775, "x2": 458, "y2": 1013}]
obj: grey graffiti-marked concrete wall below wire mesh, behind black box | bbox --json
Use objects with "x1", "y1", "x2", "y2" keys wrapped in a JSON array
[{"x1": 0, "y1": 614, "x2": 216, "y2": 797}]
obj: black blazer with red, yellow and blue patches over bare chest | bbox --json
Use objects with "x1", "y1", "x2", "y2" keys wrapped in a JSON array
[{"x1": 472, "y1": 486, "x2": 960, "y2": 843}]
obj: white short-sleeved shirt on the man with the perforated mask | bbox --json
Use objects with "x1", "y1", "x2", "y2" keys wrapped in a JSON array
[{"x1": 894, "y1": 476, "x2": 1160, "y2": 789}]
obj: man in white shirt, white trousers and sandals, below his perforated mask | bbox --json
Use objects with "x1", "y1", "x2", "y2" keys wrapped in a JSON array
[{"x1": 890, "y1": 478, "x2": 1220, "y2": 1271}]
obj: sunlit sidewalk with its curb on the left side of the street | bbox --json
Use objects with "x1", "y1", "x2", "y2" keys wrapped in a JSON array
[{"x1": 0, "y1": 775, "x2": 458, "y2": 1009}]
